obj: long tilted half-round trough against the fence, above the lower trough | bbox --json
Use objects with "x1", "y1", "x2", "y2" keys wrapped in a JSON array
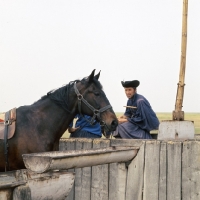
[{"x1": 22, "y1": 147, "x2": 139, "y2": 173}]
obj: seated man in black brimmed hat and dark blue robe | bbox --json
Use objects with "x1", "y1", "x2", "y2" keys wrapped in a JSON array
[{"x1": 113, "y1": 80, "x2": 159, "y2": 139}]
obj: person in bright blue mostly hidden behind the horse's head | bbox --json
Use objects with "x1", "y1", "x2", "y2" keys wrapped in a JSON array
[{"x1": 68, "y1": 114, "x2": 102, "y2": 138}]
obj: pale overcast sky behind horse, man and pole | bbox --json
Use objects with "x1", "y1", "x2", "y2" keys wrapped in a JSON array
[{"x1": 0, "y1": 0, "x2": 200, "y2": 112}]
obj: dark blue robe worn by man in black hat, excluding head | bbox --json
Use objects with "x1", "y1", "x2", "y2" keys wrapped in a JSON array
[{"x1": 113, "y1": 93, "x2": 159, "y2": 139}]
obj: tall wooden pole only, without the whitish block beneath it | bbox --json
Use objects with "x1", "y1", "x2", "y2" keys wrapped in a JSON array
[{"x1": 173, "y1": 0, "x2": 188, "y2": 121}]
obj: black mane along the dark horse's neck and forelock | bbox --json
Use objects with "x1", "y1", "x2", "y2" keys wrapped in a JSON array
[{"x1": 36, "y1": 77, "x2": 103, "y2": 113}]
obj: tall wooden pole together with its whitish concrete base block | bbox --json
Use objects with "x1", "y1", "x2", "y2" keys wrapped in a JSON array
[{"x1": 158, "y1": 0, "x2": 195, "y2": 140}]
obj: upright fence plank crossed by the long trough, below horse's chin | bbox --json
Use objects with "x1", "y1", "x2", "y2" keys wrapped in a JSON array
[{"x1": 91, "y1": 139, "x2": 110, "y2": 200}]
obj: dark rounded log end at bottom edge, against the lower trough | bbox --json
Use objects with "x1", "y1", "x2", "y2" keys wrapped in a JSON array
[{"x1": 13, "y1": 185, "x2": 32, "y2": 200}]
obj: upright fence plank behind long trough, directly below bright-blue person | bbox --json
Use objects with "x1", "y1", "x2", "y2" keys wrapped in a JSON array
[{"x1": 75, "y1": 138, "x2": 92, "y2": 200}]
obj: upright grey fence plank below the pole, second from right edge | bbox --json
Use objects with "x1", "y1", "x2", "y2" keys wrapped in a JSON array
[{"x1": 167, "y1": 141, "x2": 182, "y2": 200}]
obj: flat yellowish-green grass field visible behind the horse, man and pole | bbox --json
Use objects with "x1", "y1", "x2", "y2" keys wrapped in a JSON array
[{"x1": 62, "y1": 112, "x2": 200, "y2": 138}]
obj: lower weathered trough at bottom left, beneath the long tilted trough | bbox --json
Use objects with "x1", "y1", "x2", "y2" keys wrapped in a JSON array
[{"x1": 0, "y1": 169, "x2": 75, "y2": 200}]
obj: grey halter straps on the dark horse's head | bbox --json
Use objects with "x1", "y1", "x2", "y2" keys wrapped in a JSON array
[{"x1": 74, "y1": 83, "x2": 112, "y2": 134}]
